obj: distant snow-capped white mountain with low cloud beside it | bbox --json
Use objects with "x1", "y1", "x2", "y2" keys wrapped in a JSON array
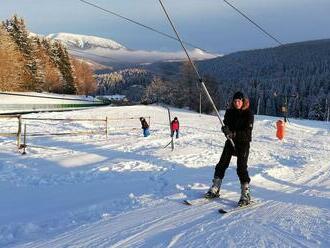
[{"x1": 47, "y1": 33, "x2": 219, "y2": 65}]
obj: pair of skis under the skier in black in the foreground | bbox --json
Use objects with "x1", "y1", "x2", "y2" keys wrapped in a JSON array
[{"x1": 183, "y1": 197, "x2": 259, "y2": 214}]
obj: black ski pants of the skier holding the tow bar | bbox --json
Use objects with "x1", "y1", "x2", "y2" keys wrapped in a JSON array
[{"x1": 214, "y1": 140, "x2": 250, "y2": 183}]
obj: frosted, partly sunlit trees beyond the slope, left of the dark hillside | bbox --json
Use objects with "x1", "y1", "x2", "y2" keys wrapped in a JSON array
[{"x1": 96, "y1": 63, "x2": 220, "y2": 113}]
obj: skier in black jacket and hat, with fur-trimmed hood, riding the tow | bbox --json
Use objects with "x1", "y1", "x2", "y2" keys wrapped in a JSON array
[{"x1": 205, "y1": 92, "x2": 254, "y2": 206}]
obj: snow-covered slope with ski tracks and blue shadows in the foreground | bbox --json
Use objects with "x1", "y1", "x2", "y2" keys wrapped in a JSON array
[{"x1": 0, "y1": 106, "x2": 330, "y2": 247}]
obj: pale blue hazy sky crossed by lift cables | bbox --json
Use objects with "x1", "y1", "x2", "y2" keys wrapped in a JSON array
[{"x1": 0, "y1": 0, "x2": 330, "y2": 53}]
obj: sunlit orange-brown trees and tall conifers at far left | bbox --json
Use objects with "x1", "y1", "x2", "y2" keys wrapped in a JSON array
[{"x1": 0, "y1": 15, "x2": 97, "y2": 95}]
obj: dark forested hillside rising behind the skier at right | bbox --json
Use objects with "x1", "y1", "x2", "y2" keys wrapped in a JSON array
[{"x1": 142, "y1": 39, "x2": 330, "y2": 120}]
